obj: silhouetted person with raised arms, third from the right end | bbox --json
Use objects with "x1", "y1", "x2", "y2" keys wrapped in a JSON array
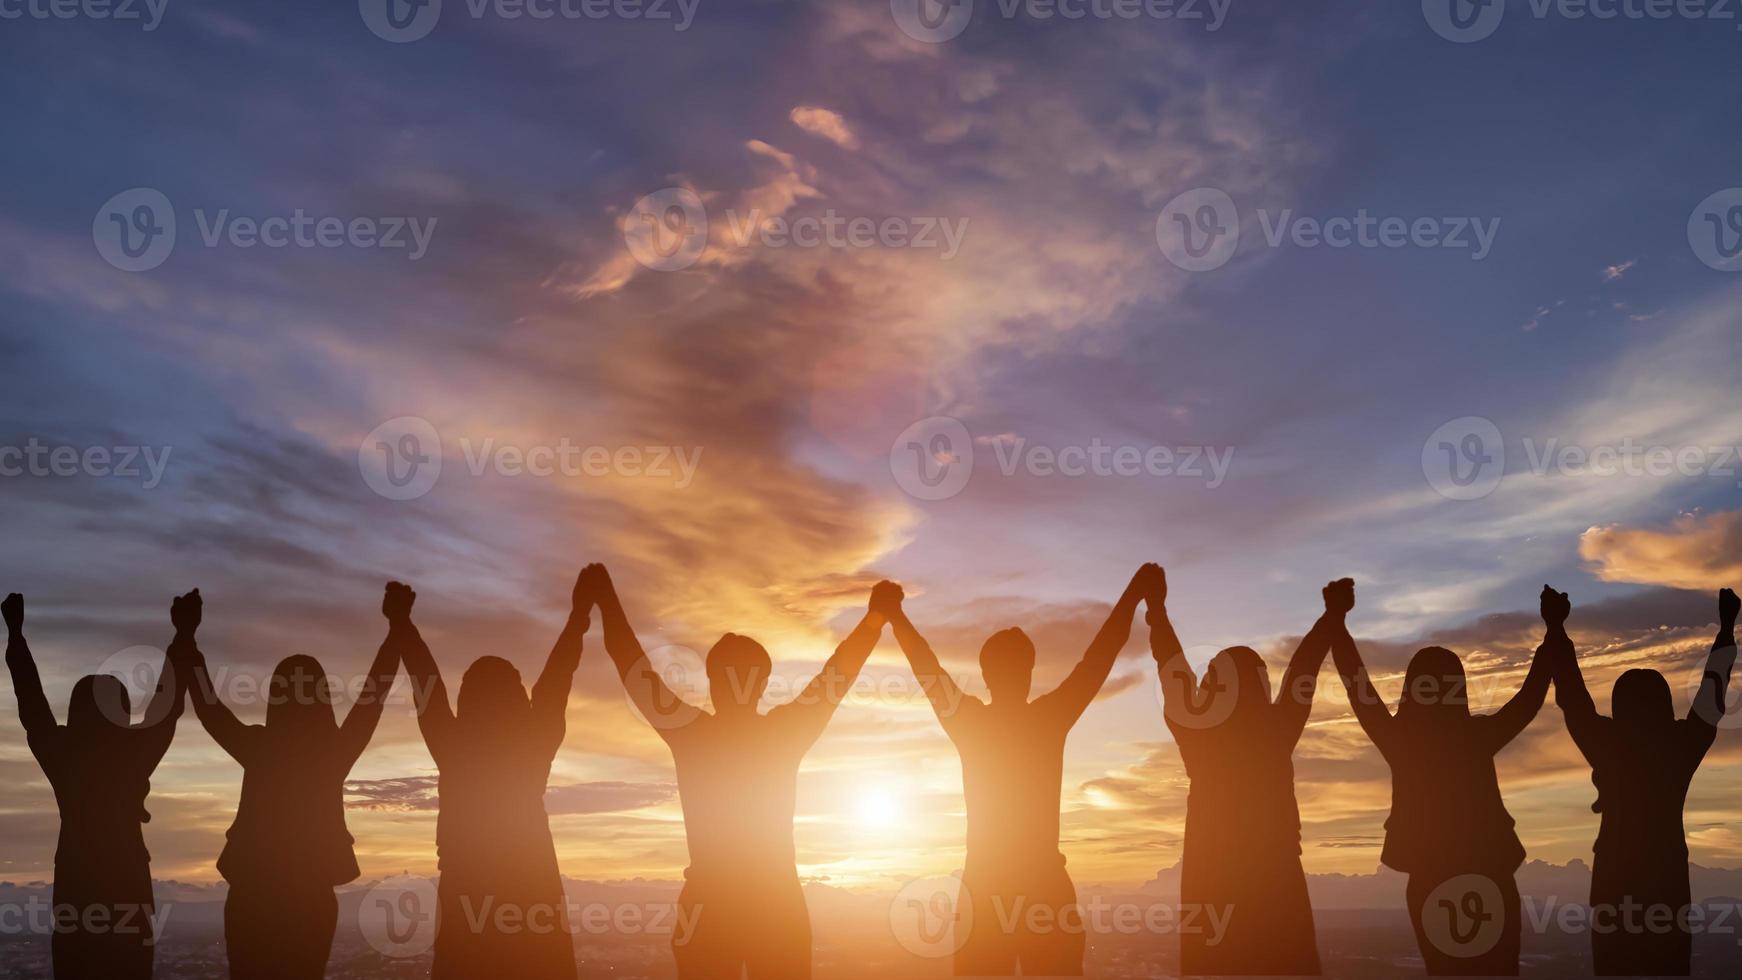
[{"x1": 1148, "y1": 578, "x2": 1355, "y2": 977}]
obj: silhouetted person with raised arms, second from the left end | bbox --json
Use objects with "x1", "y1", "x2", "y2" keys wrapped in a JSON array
[{"x1": 171, "y1": 585, "x2": 411, "y2": 980}]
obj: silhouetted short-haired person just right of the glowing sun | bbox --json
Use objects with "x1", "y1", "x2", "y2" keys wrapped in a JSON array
[{"x1": 873, "y1": 564, "x2": 1162, "y2": 977}]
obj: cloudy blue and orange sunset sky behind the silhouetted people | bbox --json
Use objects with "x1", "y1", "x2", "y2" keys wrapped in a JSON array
[{"x1": 0, "y1": 0, "x2": 1742, "y2": 888}]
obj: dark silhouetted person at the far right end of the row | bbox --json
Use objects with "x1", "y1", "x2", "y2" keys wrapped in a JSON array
[{"x1": 1543, "y1": 588, "x2": 1739, "y2": 977}]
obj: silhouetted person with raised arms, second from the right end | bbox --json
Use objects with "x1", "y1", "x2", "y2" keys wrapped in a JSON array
[{"x1": 1331, "y1": 590, "x2": 1554, "y2": 977}]
